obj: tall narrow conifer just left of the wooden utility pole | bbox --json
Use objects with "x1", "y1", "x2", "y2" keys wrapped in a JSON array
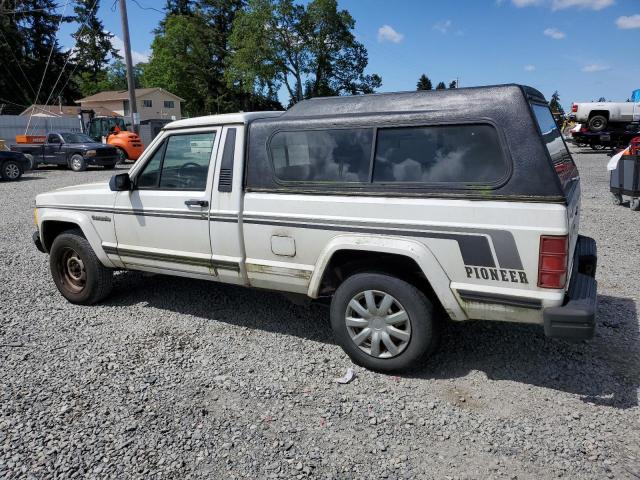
[{"x1": 72, "y1": 0, "x2": 121, "y2": 96}]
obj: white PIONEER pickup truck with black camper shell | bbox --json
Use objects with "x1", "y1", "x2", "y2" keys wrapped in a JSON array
[{"x1": 34, "y1": 85, "x2": 597, "y2": 371}]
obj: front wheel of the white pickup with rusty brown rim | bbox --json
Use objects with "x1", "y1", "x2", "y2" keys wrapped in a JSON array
[{"x1": 49, "y1": 230, "x2": 113, "y2": 305}]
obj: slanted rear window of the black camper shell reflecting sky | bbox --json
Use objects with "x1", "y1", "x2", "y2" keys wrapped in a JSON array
[{"x1": 531, "y1": 103, "x2": 578, "y2": 192}]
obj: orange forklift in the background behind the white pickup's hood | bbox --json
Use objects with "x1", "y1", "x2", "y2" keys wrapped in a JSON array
[{"x1": 80, "y1": 110, "x2": 144, "y2": 162}]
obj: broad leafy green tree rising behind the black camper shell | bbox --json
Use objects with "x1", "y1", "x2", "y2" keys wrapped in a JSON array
[{"x1": 226, "y1": 0, "x2": 382, "y2": 103}]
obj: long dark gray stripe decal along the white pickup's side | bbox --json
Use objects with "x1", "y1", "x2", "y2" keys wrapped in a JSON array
[{"x1": 38, "y1": 205, "x2": 523, "y2": 270}]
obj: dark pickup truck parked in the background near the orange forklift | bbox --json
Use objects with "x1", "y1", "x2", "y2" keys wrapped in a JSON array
[{"x1": 11, "y1": 132, "x2": 119, "y2": 172}]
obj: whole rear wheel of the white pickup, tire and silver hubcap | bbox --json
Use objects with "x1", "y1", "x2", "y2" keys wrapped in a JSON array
[{"x1": 331, "y1": 273, "x2": 438, "y2": 372}]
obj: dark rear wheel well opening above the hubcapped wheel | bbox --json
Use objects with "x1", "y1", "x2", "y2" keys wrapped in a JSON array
[{"x1": 319, "y1": 250, "x2": 441, "y2": 307}]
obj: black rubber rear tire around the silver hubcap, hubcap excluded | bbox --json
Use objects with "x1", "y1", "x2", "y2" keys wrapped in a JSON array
[{"x1": 331, "y1": 273, "x2": 438, "y2": 372}]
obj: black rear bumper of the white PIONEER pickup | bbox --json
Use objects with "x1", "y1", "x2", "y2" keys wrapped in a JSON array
[{"x1": 543, "y1": 236, "x2": 598, "y2": 340}]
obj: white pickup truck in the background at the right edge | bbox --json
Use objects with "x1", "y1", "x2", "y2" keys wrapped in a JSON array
[{"x1": 571, "y1": 90, "x2": 640, "y2": 132}]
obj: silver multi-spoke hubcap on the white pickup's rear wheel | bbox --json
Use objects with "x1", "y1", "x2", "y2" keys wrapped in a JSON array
[{"x1": 345, "y1": 290, "x2": 411, "y2": 358}]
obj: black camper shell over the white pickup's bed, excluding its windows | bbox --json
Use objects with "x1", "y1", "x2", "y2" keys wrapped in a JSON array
[{"x1": 245, "y1": 85, "x2": 577, "y2": 203}]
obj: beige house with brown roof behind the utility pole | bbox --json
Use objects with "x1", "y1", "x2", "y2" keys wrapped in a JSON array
[{"x1": 76, "y1": 88, "x2": 184, "y2": 122}]
